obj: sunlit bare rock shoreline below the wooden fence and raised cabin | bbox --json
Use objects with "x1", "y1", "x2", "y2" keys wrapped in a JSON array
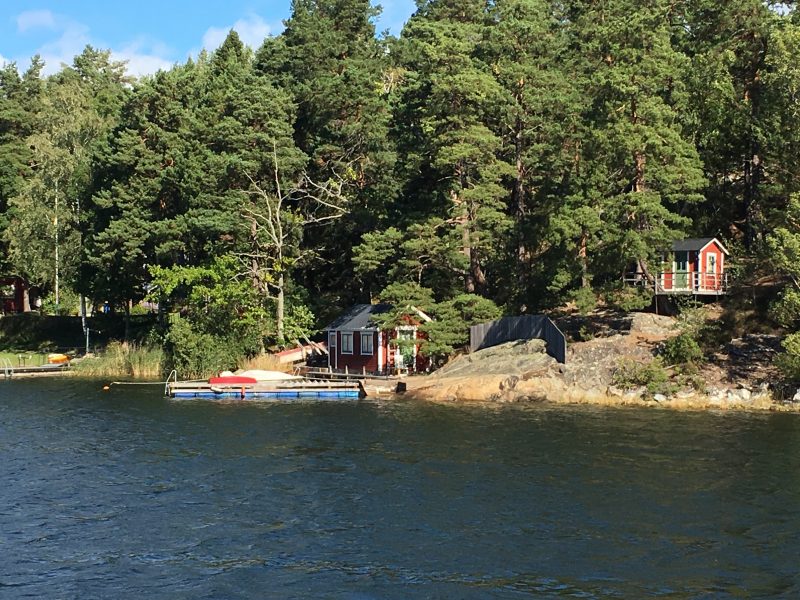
[{"x1": 406, "y1": 313, "x2": 800, "y2": 412}]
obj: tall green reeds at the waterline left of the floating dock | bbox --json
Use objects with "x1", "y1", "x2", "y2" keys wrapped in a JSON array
[{"x1": 71, "y1": 341, "x2": 164, "y2": 379}]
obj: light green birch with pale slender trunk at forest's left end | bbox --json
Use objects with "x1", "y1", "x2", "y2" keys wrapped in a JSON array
[{"x1": 6, "y1": 46, "x2": 127, "y2": 305}]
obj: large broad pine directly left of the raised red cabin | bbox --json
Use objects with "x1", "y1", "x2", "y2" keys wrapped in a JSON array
[{"x1": 570, "y1": 0, "x2": 703, "y2": 278}]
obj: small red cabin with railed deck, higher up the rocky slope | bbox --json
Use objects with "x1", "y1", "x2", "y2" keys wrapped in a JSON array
[{"x1": 655, "y1": 238, "x2": 728, "y2": 296}]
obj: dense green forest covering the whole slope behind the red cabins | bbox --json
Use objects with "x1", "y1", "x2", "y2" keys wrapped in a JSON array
[{"x1": 0, "y1": 0, "x2": 800, "y2": 372}]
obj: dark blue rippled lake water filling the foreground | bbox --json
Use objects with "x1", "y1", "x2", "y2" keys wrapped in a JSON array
[{"x1": 0, "y1": 379, "x2": 800, "y2": 600}]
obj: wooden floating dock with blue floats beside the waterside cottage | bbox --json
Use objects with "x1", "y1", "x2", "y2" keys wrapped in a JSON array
[{"x1": 165, "y1": 379, "x2": 366, "y2": 400}]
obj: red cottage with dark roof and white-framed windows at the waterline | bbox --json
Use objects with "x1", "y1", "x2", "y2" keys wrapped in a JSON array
[{"x1": 324, "y1": 304, "x2": 431, "y2": 374}]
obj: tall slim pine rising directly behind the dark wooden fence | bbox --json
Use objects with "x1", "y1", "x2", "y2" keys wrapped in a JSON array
[{"x1": 481, "y1": 0, "x2": 580, "y2": 308}]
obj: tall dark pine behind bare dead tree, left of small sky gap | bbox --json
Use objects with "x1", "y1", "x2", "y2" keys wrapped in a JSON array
[{"x1": 256, "y1": 0, "x2": 398, "y2": 306}]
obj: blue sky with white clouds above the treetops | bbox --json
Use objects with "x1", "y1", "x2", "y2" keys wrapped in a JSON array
[{"x1": 0, "y1": 0, "x2": 415, "y2": 75}]
